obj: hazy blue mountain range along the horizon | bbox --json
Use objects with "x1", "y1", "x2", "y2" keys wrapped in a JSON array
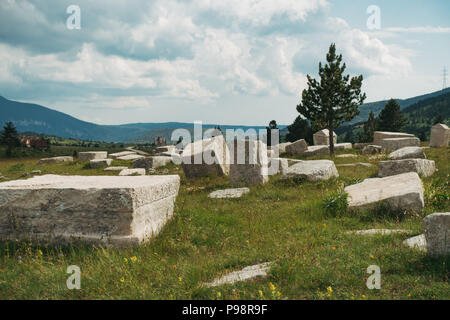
[{"x1": 0, "y1": 88, "x2": 450, "y2": 143}]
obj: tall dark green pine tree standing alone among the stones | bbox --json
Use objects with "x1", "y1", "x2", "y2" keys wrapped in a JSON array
[{"x1": 297, "y1": 43, "x2": 366, "y2": 155}]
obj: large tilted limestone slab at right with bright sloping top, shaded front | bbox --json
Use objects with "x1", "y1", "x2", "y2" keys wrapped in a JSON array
[{"x1": 344, "y1": 172, "x2": 424, "y2": 212}]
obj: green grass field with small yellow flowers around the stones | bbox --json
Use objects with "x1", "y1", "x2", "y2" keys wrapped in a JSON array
[{"x1": 0, "y1": 148, "x2": 450, "y2": 299}]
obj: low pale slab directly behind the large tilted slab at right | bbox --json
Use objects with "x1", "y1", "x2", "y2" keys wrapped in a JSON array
[{"x1": 378, "y1": 159, "x2": 436, "y2": 177}]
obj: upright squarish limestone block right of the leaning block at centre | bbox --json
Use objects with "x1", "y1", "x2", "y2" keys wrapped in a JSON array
[{"x1": 230, "y1": 139, "x2": 268, "y2": 186}]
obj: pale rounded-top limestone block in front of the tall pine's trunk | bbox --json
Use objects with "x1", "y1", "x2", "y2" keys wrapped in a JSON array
[{"x1": 283, "y1": 160, "x2": 339, "y2": 181}]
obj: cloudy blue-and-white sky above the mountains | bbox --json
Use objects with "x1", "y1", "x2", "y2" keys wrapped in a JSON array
[{"x1": 0, "y1": 0, "x2": 450, "y2": 125}]
